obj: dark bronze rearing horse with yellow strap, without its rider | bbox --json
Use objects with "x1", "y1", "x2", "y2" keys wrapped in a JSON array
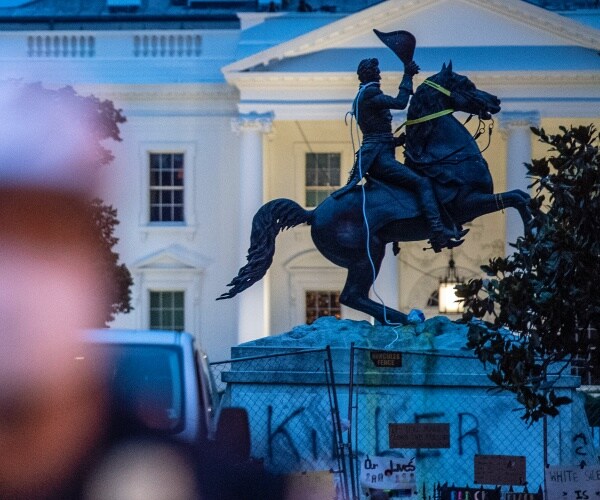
[{"x1": 217, "y1": 63, "x2": 532, "y2": 324}]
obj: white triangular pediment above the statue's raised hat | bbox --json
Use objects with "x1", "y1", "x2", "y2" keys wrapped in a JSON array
[{"x1": 223, "y1": 0, "x2": 600, "y2": 77}]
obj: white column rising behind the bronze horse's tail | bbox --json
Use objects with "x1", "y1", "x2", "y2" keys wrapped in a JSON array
[{"x1": 231, "y1": 113, "x2": 273, "y2": 343}]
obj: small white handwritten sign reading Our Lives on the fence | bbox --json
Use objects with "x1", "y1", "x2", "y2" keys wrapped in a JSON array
[{"x1": 360, "y1": 455, "x2": 417, "y2": 495}]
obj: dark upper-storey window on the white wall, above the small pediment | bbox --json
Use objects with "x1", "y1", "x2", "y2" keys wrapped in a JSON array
[{"x1": 149, "y1": 153, "x2": 184, "y2": 222}]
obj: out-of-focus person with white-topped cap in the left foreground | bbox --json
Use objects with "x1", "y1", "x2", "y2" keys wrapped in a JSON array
[{"x1": 0, "y1": 81, "x2": 198, "y2": 500}]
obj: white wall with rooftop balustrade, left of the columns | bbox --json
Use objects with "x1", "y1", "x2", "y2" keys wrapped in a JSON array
[{"x1": 0, "y1": 25, "x2": 245, "y2": 359}]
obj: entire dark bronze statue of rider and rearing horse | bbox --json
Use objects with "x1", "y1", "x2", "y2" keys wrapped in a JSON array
[{"x1": 217, "y1": 30, "x2": 532, "y2": 325}]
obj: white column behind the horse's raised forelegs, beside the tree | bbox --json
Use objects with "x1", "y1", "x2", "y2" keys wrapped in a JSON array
[{"x1": 500, "y1": 111, "x2": 540, "y2": 256}]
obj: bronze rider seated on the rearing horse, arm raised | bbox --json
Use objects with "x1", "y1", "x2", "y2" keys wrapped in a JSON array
[{"x1": 333, "y1": 52, "x2": 466, "y2": 252}]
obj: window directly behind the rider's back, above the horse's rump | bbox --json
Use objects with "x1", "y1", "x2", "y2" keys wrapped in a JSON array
[{"x1": 305, "y1": 152, "x2": 342, "y2": 207}]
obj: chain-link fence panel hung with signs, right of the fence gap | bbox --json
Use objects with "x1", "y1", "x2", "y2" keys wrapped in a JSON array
[{"x1": 347, "y1": 346, "x2": 598, "y2": 498}]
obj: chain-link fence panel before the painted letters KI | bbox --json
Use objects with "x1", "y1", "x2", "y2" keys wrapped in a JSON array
[{"x1": 210, "y1": 347, "x2": 347, "y2": 497}]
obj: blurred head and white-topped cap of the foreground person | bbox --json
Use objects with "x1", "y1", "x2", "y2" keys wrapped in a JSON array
[{"x1": 0, "y1": 85, "x2": 112, "y2": 498}]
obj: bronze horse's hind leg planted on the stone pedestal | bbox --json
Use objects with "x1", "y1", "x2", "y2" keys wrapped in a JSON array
[{"x1": 340, "y1": 245, "x2": 408, "y2": 325}]
